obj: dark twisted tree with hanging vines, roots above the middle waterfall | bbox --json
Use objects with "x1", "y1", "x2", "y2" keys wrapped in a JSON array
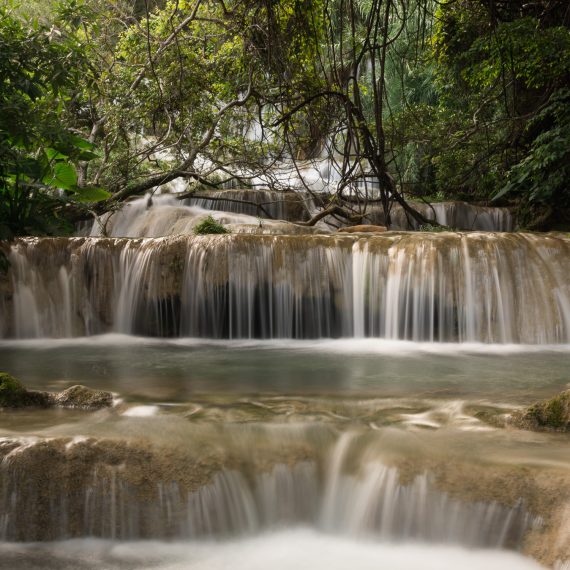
[{"x1": 260, "y1": 0, "x2": 438, "y2": 225}]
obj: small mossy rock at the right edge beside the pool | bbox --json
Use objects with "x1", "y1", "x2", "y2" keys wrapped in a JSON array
[{"x1": 510, "y1": 390, "x2": 570, "y2": 432}]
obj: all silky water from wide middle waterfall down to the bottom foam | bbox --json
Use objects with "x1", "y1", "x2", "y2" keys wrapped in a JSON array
[{"x1": 0, "y1": 229, "x2": 570, "y2": 570}]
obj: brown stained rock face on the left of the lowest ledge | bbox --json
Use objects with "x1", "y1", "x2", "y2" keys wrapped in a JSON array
[{"x1": 0, "y1": 432, "x2": 312, "y2": 541}]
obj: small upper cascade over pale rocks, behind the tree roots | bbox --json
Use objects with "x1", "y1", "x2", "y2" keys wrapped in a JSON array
[{"x1": 79, "y1": 189, "x2": 514, "y2": 237}]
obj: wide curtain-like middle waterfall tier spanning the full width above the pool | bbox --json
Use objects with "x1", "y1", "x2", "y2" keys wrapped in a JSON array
[{"x1": 0, "y1": 233, "x2": 570, "y2": 344}]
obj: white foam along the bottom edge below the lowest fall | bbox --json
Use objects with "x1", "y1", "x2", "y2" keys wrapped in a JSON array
[{"x1": 0, "y1": 529, "x2": 543, "y2": 570}]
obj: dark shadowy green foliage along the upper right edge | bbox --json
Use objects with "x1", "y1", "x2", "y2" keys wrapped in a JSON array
[{"x1": 398, "y1": 0, "x2": 570, "y2": 228}]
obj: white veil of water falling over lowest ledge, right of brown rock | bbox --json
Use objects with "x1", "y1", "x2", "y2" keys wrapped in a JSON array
[{"x1": 183, "y1": 463, "x2": 531, "y2": 548}]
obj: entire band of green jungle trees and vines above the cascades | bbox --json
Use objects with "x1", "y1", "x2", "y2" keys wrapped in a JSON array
[{"x1": 0, "y1": 0, "x2": 570, "y2": 232}]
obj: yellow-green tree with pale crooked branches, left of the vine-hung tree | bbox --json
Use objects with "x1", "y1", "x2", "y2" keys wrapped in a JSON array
[{"x1": 67, "y1": 0, "x2": 278, "y2": 204}]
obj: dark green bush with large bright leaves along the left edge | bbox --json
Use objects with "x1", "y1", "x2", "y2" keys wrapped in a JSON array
[{"x1": 0, "y1": 9, "x2": 108, "y2": 243}]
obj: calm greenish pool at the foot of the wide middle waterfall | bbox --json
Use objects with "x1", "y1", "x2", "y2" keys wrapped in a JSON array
[{"x1": 0, "y1": 335, "x2": 570, "y2": 404}]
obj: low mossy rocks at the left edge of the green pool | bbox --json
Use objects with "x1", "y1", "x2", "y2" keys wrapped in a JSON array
[{"x1": 0, "y1": 372, "x2": 113, "y2": 410}]
